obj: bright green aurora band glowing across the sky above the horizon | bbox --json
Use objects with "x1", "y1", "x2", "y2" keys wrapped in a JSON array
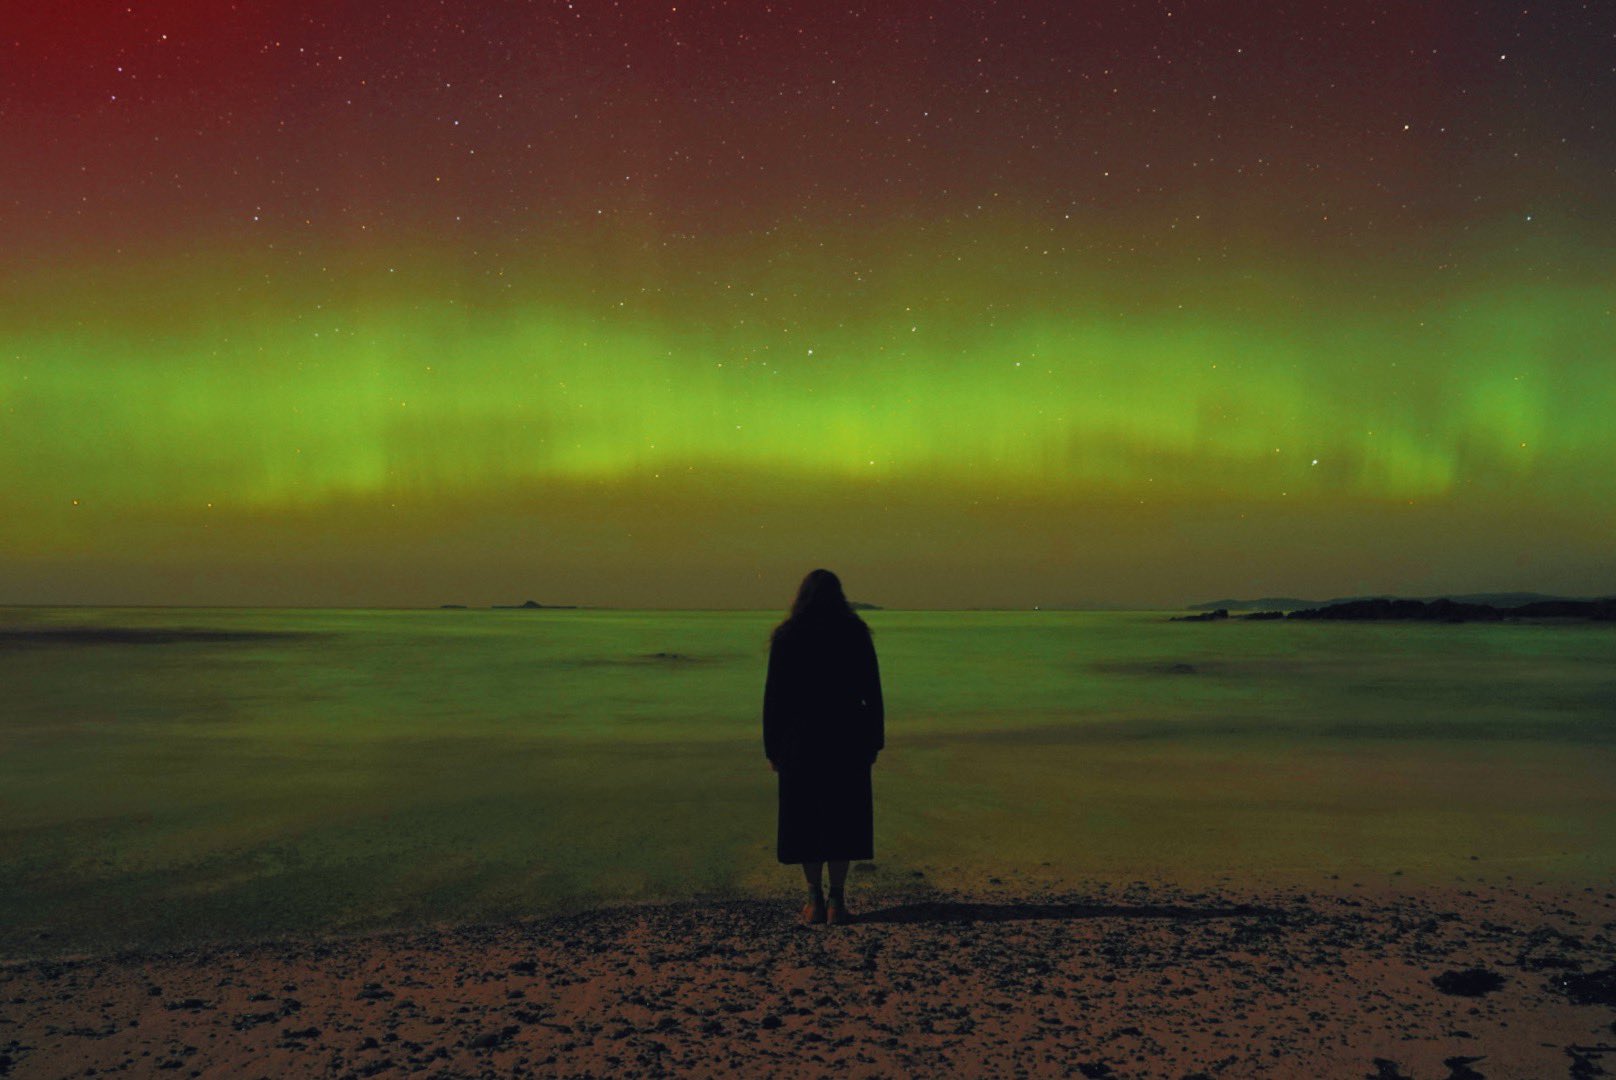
[{"x1": 0, "y1": 223, "x2": 1616, "y2": 603}]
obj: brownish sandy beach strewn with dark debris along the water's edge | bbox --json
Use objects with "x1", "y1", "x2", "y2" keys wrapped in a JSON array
[{"x1": 0, "y1": 873, "x2": 1616, "y2": 1080}]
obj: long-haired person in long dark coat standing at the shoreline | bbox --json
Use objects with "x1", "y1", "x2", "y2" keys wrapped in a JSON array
[{"x1": 763, "y1": 569, "x2": 886, "y2": 925}]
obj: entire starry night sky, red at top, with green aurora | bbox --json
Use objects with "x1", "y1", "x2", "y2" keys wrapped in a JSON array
[{"x1": 0, "y1": 0, "x2": 1616, "y2": 608}]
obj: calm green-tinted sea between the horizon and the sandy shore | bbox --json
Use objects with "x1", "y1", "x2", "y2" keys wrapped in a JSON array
[{"x1": 0, "y1": 608, "x2": 1616, "y2": 956}]
